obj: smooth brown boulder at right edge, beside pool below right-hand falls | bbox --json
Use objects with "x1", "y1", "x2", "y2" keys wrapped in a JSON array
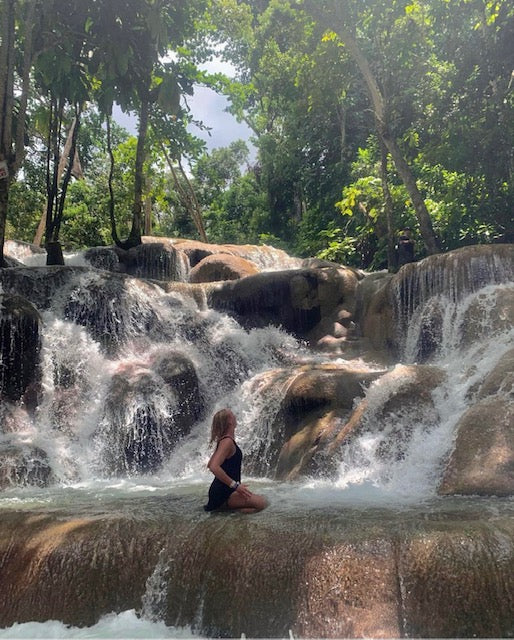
[{"x1": 439, "y1": 350, "x2": 514, "y2": 496}]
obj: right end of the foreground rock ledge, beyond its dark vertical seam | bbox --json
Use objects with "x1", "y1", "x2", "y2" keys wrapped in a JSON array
[{"x1": 397, "y1": 516, "x2": 514, "y2": 638}]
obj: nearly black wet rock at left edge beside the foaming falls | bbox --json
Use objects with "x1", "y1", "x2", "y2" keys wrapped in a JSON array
[{"x1": 0, "y1": 294, "x2": 41, "y2": 404}]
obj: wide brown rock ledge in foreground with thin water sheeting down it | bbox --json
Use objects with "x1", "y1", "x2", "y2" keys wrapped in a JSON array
[{"x1": 0, "y1": 497, "x2": 514, "y2": 638}]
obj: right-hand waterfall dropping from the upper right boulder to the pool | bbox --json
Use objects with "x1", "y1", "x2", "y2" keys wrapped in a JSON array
[{"x1": 330, "y1": 245, "x2": 514, "y2": 500}]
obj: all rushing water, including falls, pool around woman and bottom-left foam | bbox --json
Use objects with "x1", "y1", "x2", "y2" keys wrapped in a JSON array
[{"x1": 0, "y1": 244, "x2": 514, "y2": 638}]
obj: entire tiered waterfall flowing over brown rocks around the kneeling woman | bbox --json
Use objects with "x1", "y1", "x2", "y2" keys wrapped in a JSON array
[{"x1": 0, "y1": 242, "x2": 514, "y2": 637}]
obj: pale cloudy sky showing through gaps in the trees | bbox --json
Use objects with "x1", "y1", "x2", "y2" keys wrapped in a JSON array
[{"x1": 113, "y1": 60, "x2": 252, "y2": 155}]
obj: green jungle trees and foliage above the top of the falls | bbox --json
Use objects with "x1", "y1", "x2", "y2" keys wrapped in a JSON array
[{"x1": 0, "y1": 0, "x2": 514, "y2": 269}]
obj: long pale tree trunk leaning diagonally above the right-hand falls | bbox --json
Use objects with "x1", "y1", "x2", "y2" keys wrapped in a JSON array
[{"x1": 327, "y1": 4, "x2": 440, "y2": 254}]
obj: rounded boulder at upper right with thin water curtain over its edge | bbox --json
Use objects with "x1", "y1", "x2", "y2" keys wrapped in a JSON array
[{"x1": 358, "y1": 244, "x2": 514, "y2": 362}]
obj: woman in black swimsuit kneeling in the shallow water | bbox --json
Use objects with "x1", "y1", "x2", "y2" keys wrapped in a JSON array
[{"x1": 204, "y1": 409, "x2": 267, "y2": 513}]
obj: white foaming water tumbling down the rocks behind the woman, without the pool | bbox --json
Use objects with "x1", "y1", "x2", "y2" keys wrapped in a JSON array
[{"x1": 0, "y1": 252, "x2": 514, "y2": 504}]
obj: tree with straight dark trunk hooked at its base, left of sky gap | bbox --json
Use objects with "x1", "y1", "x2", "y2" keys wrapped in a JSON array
[{"x1": 87, "y1": 0, "x2": 203, "y2": 249}]
